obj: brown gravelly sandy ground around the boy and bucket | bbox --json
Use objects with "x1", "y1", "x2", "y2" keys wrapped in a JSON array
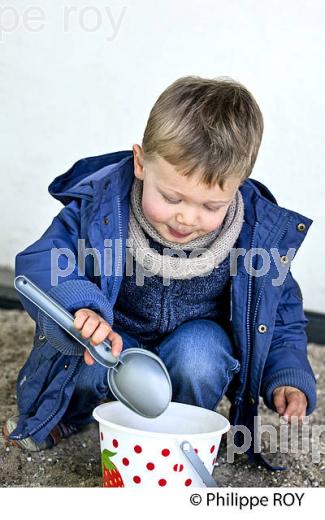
[{"x1": 0, "y1": 310, "x2": 325, "y2": 487}]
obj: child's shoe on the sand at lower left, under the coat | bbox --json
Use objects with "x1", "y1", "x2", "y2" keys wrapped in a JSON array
[{"x1": 2, "y1": 416, "x2": 80, "y2": 451}]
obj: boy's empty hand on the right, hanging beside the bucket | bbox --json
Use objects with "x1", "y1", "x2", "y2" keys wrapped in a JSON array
[{"x1": 273, "y1": 386, "x2": 307, "y2": 422}]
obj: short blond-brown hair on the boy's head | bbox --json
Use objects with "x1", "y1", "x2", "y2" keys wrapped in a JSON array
[{"x1": 142, "y1": 76, "x2": 263, "y2": 189}]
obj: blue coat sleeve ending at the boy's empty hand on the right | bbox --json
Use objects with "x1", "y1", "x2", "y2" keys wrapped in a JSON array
[{"x1": 260, "y1": 271, "x2": 317, "y2": 415}]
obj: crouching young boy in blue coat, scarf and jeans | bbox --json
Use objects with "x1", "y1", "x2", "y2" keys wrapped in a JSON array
[{"x1": 3, "y1": 76, "x2": 316, "y2": 464}]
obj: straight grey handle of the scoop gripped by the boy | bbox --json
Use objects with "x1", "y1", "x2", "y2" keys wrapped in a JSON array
[{"x1": 14, "y1": 275, "x2": 119, "y2": 368}]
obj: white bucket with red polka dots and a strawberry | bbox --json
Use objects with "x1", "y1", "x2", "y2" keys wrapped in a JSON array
[{"x1": 93, "y1": 401, "x2": 230, "y2": 487}]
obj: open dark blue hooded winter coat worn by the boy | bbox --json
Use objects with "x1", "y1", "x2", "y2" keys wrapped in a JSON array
[{"x1": 10, "y1": 150, "x2": 316, "y2": 468}]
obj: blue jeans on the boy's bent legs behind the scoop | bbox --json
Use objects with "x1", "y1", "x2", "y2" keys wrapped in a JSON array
[{"x1": 62, "y1": 319, "x2": 240, "y2": 426}]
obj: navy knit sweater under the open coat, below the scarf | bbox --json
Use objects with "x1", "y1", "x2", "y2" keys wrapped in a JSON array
[{"x1": 114, "y1": 232, "x2": 230, "y2": 347}]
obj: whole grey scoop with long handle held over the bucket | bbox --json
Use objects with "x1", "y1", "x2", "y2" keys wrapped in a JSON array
[{"x1": 14, "y1": 275, "x2": 172, "y2": 418}]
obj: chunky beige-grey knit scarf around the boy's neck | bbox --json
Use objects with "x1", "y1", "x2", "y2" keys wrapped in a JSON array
[{"x1": 127, "y1": 177, "x2": 244, "y2": 279}]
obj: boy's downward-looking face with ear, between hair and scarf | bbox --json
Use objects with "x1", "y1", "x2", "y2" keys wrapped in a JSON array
[{"x1": 133, "y1": 145, "x2": 241, "y2": 244}]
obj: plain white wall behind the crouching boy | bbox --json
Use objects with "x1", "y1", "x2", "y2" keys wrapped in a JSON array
[{"x1": 0, "y1": 0, "x2": 325, "y2": 312}]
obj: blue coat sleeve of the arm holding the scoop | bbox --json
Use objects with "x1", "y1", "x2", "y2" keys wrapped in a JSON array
[{"x1": 15, "y1": 200, "x2": 113, "y2": 352}]
